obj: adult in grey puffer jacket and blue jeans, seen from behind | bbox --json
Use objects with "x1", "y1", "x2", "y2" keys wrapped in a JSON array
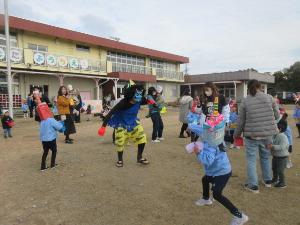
[{"x1": 234, "y1": 80, "x2": 280, "y2": 193}]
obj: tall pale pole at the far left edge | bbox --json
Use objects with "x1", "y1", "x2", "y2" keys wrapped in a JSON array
[{"x1": 4, "y1": 0, "x2": 13, "y2": 117}]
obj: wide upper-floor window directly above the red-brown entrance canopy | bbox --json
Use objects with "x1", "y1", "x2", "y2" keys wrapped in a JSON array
[{"x1": 106, "y1": 52, "x2": 145, "y2": 66}]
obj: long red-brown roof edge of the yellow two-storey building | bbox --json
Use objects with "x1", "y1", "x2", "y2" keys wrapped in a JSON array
[{"x1": 0, "y1": 14, "x2": 189, "y2": 63}]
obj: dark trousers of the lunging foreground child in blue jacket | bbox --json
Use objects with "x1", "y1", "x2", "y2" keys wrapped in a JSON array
[{"x1": 202, "y1": 172, "x2": 239, "y2": 216}]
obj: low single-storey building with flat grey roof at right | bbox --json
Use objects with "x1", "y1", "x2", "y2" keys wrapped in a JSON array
[{"x1": 181, "y1": 69, "x2": 275, "y2": 102}]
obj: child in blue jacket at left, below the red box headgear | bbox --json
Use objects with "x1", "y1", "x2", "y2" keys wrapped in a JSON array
[{"x1": 40, "y1": 118, "x2": 64, "y2": 171}]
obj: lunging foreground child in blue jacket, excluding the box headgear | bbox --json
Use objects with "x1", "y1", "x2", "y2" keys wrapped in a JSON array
[{"x1": 194, "y1": 142, "x2": 249, "y2": 225}]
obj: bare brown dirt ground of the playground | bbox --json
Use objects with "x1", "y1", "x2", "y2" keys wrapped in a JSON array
[{"x1": 0, "y1": 106, "x2": 300, "y2": 225}]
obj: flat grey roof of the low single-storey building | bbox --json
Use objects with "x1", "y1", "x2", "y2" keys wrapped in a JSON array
[{"x1": 184, "y1": 69, "x2": 275, "y2": 84}]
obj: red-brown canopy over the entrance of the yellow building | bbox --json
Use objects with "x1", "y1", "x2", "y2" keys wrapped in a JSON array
[{"x1": 107, "y1": 72, "x2": 156, "y2": 83}]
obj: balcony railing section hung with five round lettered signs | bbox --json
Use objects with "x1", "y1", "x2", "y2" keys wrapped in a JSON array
[{"x1": 33, "y1": 51, "x2": 106, "y2": 72}]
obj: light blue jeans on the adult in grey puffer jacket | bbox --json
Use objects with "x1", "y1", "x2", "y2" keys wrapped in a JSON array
[{"x1": 245, "y1": 138, "x2": 272, "y2": 186}]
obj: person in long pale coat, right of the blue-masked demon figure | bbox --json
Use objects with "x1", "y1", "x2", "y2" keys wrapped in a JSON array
[{"x1": 179, "y1": 89, "x2": 193, "y2": 138}]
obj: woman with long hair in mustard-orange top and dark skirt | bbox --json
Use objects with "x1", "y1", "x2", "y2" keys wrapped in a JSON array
[{"x1": 57, "y1": 86, "x2": 76, "y2": 144}]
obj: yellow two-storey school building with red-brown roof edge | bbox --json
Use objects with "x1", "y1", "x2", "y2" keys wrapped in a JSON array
[{"x1": 0, "y1": 16, "x2": 189, "y2": 107}]
